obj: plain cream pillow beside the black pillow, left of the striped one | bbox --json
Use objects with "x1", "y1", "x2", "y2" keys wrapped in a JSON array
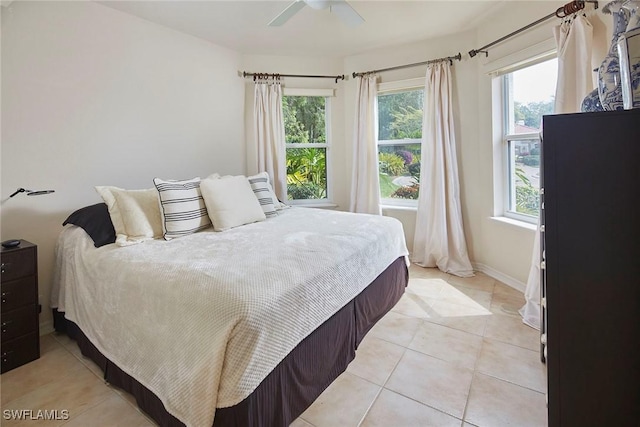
[{"x1": 95, "y1": 186, "x2": 162, "y2": 246}]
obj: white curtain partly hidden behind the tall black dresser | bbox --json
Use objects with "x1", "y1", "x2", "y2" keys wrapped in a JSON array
[{"x1": 520, "y1": 14, "x2": 593, "y2": 329}]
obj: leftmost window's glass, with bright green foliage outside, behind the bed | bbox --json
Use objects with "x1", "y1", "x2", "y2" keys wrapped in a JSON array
[{"x1": 282, "y1": 90, "x2": 330, "y2": 204}]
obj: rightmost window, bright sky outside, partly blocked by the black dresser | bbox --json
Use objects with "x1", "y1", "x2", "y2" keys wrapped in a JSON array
[{"x1": 500, "y1": 58, "x2": 558, "y2": 223}]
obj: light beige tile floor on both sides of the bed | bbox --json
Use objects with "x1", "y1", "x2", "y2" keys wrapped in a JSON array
[{"x1": 0, "y1": 265, "x2": 547, "y2": 427}]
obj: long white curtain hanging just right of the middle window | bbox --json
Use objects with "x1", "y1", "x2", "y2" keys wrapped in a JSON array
[{"x1": 412, "y1": 61, "x2": 473, "y2": 277}]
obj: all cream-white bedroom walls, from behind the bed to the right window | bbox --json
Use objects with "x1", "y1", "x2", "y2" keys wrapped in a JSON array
[{"x1": 0, "y1": 1, "x2": 611, "y2": 336}]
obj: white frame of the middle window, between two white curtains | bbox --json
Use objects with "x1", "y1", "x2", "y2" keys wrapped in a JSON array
[{"x1": 376, "y1": 78, "x2": 425, "y2": 209}]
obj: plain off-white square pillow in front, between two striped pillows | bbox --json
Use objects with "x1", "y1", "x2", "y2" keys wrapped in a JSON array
[{"x1": 200, "y1": 175, "x2": 266, "y2": 231}]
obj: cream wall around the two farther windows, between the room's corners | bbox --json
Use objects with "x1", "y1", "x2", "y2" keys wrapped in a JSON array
[{"x1": 243, "y1": 27, "x2": 478, "y2": 264}]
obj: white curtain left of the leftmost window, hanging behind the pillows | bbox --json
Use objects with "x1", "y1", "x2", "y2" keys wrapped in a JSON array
[{"x1": 253, "y1": 80, "x2": 287, "y2": 200}]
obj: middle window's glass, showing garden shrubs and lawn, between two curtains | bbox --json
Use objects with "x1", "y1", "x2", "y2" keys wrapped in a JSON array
[{"x1": 378, "y1": 88, "x2": 424, "y2": 206}]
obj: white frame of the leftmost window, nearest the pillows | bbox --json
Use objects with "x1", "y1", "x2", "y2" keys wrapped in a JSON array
[{"x1": 282, "y1": 87, "x2": 335, "y2": 207}]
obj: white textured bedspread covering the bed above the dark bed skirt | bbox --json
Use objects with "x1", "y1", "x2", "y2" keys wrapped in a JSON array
[{"x1": 52, "y1": 208, "x2": 408, "y2": 427}]
